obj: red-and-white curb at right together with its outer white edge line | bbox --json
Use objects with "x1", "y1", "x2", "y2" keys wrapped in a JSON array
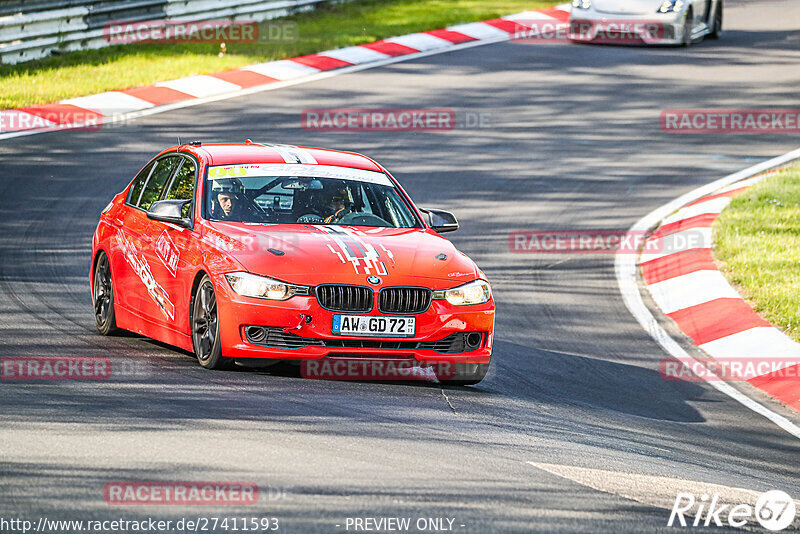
[{"x1": 615, "y1": 150, "x2": 800, "y2": 438}]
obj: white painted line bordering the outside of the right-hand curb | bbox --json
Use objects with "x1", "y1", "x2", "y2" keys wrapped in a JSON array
[{"x1": 614, "y1": 149, "x2": 800, "y2": 439}]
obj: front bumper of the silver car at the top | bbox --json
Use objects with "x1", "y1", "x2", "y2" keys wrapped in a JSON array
[{"x1": 569, "y1": 9, "x2": 686, "y2": 45}]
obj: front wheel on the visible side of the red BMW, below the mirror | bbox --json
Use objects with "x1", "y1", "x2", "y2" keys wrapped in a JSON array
[{"x1": 192, "y1": 275, "x2": 229, "y2": 369}]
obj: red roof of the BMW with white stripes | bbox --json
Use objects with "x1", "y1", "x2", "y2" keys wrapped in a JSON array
[{"x1": 162, "y1": 142, "x2": 382, "y2": 171}]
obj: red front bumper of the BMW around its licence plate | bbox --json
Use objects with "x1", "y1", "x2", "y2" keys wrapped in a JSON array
[{"x1": 214, "y1": 277, "x2": 494, "y2": 363}]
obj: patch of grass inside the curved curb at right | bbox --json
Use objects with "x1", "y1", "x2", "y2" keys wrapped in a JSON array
[{"x1": 714, "y1": 166, "x2": 800, "y2": 341}]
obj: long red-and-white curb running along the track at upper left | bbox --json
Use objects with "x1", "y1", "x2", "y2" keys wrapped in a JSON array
[{"x1": 0, "y1": 4, "x2": 569, "y2": 139}]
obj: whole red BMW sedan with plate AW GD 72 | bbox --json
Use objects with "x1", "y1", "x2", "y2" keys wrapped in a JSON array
[{"x1": 90, "y1": 140, "x2": 495, "y2": 384}]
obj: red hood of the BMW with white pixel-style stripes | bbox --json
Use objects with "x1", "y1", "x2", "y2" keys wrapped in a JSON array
[{"x1": 202, "y1": 222, "x2": 480, "y2": 288}]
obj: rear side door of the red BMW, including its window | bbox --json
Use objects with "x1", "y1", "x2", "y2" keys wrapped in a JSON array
[{"x1": 117, "y1": 155, "x2": 182, "y2": 324}]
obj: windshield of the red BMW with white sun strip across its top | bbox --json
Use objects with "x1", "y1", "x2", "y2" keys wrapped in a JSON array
[{"x1": 204, "y1": 164, "x2": 419, "y2": 228}]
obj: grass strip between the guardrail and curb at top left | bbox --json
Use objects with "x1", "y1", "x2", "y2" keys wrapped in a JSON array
[{"x1": 0, "y1": 0, "x2": 555, "y2": 109}]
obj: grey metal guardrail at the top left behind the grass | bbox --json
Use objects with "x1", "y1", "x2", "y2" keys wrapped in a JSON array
[{"x1": 0, "y1": 0, "x2": 341, "y2": 63}]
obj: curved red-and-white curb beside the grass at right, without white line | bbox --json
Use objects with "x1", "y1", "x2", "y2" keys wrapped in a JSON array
[{"x1": 639, "y1": 175, "x2": 800, "y2": 410}]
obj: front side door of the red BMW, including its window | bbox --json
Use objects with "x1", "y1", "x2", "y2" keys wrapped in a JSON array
[{"x1": 144, "y1": 155, "x2": 198, "y2": 334}]
